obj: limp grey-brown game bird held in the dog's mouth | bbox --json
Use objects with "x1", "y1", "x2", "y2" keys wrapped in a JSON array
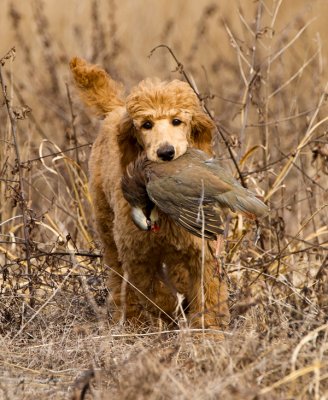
[{"x1": 121, "y1": 148, "x2": 269, "y2": 240}]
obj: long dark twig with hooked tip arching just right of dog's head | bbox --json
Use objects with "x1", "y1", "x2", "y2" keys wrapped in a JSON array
[{"x1": 149, "y1": 44, "x2": 247, "y2": 187}]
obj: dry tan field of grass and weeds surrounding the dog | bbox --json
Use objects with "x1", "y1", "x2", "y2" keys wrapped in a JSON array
[{"x1": 0, "y1": 0, "x2": 328, "y2": 400}]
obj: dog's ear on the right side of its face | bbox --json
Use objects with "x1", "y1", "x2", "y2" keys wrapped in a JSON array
[{"x1": 191, "y1": 111, "x2": 215, "y2": 154}]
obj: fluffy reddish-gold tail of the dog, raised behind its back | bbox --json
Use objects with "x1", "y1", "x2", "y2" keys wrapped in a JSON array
[{"x1": 70, "y1": 57, "x2": 124, "y2": 116}]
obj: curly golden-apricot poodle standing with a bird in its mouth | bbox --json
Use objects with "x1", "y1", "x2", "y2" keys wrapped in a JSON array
[{"x1": 70, "y1": 58, "x2": 229, "y2": 328}]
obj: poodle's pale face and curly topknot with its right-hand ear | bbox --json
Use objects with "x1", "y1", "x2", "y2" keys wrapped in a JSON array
[{"x1": 121, "y1": 79, "x2": 214, "y2": 167}]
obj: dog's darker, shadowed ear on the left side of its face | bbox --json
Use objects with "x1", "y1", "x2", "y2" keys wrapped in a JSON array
[{"x1": 117, "y1": 114, "x2": 142, "y2": 171}]
